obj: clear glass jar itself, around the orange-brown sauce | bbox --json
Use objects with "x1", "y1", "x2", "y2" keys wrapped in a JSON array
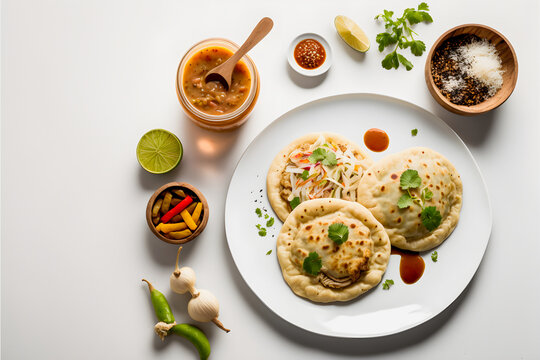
[{"x1": 176, "y1": 38, "x2": 260, "y2": 131}]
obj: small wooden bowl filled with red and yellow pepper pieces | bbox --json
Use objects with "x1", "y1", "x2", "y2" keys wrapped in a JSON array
[{"x1": 146, "y1": 182, "x2": 209, "y2": 244}]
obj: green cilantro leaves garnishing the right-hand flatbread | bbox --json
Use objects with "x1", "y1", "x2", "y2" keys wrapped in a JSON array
[{"x1": 398, "y1": 169, "x2": 442, "y2": 231}]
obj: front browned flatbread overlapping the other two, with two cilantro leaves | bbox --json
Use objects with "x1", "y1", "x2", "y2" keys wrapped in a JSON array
[{"x1": 277, "y1": 199, "x2": 390, "y2": 302}]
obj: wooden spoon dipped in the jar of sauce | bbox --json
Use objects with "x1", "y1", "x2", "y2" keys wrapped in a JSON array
[{"x1": 204, "y1": 17, "x2": 274, "y2": 90}]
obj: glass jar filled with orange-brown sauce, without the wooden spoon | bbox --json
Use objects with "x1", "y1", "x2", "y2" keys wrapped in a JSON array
[{"x1": 176, "y1": 38, "x2": 260, "y2": 131}]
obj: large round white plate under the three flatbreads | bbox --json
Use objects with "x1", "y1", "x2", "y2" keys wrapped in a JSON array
[{"x1": 225, "y1": 94, "x2": 492, "y2": 338}]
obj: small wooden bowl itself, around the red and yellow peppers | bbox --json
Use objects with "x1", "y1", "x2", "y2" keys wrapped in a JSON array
[{"x1": 146, "y1": 182, "x2": 209, "y2": 244}]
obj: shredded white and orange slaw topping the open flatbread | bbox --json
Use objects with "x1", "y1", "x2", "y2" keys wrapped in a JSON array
[{"x1": 285, "y1": 135, "x2": 363, "y2": 202}]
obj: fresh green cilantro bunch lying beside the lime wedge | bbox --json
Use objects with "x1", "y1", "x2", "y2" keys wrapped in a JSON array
[{"x1": 375, "y1": 2, "x2": 433, "y2": 71}]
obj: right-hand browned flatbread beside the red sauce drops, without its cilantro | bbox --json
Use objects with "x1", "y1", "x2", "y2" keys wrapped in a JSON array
[{"x1": 358, "y1": 147, "x2": 463, "y2": 251}]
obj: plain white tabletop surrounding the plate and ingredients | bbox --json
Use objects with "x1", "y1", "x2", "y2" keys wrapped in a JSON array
[{"x1": 1, "y1": 0, "x2": 540, "y2": 360}]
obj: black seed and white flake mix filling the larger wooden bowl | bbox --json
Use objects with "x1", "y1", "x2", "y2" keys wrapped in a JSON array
[{"x1": 431, "y1": 34, "x2": 504, "y2": 106}]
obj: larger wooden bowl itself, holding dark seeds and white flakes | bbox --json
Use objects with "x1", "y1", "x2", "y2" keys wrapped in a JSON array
[{"x1": 425, "y1": 24, "x2": 518, "y2": 115}]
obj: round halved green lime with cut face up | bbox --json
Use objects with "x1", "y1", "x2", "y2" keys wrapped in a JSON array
[{"x1": 137, "y1": 129, "x2": 183, "y2": 174}]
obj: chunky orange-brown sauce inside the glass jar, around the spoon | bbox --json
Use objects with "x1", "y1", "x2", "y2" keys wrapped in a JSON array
[{"x1": 183, "y1": 46, "x2": 251, "y2": 115}]
